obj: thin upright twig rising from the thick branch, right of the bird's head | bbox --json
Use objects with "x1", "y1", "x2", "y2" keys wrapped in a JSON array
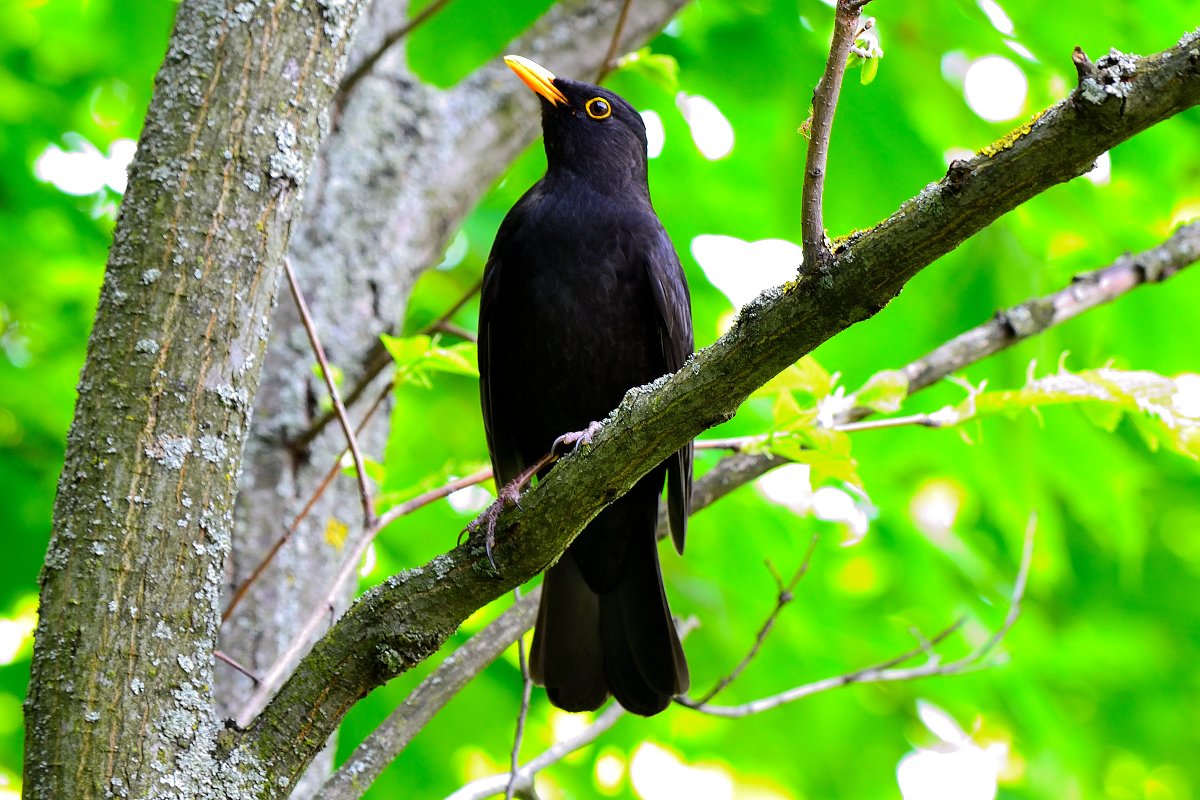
[{"x1": 800, "y1": 0, "x2": 869, "y2": 272}]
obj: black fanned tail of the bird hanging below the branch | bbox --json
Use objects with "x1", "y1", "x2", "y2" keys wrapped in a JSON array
[{"x1": 530, "y1": 522, "x2": 689, "y2": 716}]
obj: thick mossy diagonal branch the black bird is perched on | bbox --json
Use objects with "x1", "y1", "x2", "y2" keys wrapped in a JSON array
[{"x1": 229, "y1": 32, "x2": 1200, "y2": 786}]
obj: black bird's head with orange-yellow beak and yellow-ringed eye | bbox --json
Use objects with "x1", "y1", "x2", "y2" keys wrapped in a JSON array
[{"x1": 504, "y1": 55, "x2": 646, "y2": 188}]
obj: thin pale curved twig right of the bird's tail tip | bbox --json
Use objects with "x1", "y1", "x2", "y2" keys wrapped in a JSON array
[{"x1": 677, "y1": 515, "x2": 1037, "y2": 718}]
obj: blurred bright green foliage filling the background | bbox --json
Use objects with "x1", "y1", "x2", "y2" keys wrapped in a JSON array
[{"x1": 0, "y1": 0, "x2": 1200, "y2": 800}]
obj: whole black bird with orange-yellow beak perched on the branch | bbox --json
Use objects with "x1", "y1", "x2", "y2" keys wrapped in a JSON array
[{"x1": 479, "y1": 55, "x2": 692, "y2": 716}]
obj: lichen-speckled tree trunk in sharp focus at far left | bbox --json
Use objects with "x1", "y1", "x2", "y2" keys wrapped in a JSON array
[{"x1": 24, "y1": 0, "x2": 361, "y2": 800}]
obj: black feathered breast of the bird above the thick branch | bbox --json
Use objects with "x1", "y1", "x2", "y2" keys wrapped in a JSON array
[{"x1": 491, "y1": 197, "x2": 666, "y2": 449}]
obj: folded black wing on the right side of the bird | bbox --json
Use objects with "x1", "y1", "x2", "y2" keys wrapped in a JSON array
[{"x1": 647, "y1": 221, "x2": 695, "y2": 553}]
